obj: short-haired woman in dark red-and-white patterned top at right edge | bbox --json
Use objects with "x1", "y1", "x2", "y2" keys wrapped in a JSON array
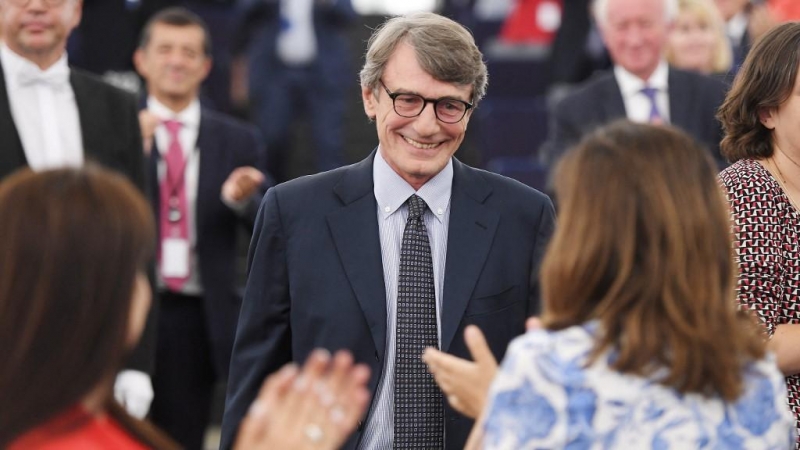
[{"x1": 718, "y1": 23, "x2": 800, "y2": 448}]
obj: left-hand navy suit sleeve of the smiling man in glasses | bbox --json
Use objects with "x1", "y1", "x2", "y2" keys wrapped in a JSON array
[{"x1": 220, "y1": 188, "x2": 292, "y2": 449}]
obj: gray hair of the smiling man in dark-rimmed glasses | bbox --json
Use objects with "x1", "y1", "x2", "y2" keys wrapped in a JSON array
[{"x1": 360, "y1": 13, "x2": 488, "y2": 106}]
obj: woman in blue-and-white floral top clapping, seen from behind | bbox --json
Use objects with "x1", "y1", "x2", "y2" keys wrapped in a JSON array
[{"x1": 426, "y1": 121, "x2": 795, "y2": 449}]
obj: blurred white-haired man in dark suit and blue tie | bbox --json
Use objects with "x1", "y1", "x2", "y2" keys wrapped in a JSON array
[{"x1": 540, "y1": 0, "x2": 725, "y2": 165}]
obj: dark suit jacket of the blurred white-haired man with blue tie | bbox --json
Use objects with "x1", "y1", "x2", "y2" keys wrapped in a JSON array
[{"x1": 540, "y1": 67, "x2": 726, "y2": 166}]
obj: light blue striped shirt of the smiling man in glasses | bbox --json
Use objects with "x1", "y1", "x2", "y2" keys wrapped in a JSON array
[{"x1": 360, "y1": 149, "x2": 453, "y2": 450}]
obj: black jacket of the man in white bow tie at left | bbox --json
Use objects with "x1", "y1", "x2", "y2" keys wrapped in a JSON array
[{"x1": 0, "y1": 61, "x2": 157, "y2": 373}]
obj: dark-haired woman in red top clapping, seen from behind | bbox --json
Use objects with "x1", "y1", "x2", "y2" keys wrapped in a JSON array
[{"x1": 0, "y1": 167, "x2": 369, "y2": 450}]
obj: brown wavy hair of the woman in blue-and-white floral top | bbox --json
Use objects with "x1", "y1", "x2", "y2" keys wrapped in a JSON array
[{"x1": 541, "y1": 121, "x2": 764, "y2": 400}]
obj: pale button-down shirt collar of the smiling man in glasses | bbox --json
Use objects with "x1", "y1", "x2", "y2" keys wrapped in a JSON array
[{"x1": 372, "y1": 148, "x2": 453, "y2": 222}]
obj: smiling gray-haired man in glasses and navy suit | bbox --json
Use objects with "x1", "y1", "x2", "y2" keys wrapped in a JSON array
[{"x1": 222, "y1": 13, "x2": 554, "y2": 449}]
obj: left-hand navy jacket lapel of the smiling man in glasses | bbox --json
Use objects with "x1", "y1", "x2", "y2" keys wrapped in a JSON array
[{"x1": 327, "y1": 151, "x2": 386, "y2": 359}]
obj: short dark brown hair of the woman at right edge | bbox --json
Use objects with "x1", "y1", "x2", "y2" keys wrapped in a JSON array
[{"x1": 717, "y1": 22, "x2": 800, "y2": 162}]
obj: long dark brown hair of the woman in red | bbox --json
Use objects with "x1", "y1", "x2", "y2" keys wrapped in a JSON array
[{"x1": 0, "y1": 166, "x2": 163, "y2": 448}]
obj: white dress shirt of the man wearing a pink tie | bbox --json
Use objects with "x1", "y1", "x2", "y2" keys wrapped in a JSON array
[{"x1": 147, "y1": 96, "x2": 203, "y2": 296}]
